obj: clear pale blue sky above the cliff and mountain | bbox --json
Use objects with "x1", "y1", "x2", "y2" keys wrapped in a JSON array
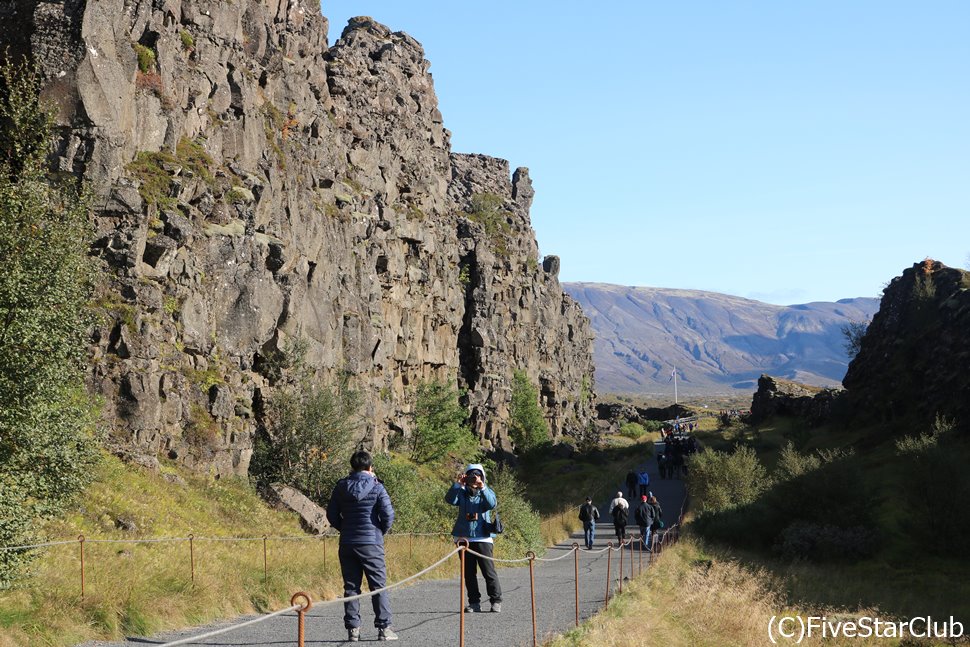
[{"x1": 322, "y1": 0, "x2": 970, "y2": 304}]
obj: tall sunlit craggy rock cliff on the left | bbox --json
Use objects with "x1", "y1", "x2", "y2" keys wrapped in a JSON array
[{"x1": 0, "y1": 0, "x2": 593, "y2": 475}]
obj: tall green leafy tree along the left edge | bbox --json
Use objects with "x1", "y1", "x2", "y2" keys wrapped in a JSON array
[{"x1": 0, "y1": 61, "x2": 98, "y2": 585}]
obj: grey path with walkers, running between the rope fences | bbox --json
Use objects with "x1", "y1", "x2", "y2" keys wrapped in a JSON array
[{"x1": 88, "y1": 446, "x2": 684, "y2": 647}]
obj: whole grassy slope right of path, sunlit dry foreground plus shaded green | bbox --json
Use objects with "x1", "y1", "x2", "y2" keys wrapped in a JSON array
[{"x1": 552, "y1": 418, "x2": 970, "y2": 647}]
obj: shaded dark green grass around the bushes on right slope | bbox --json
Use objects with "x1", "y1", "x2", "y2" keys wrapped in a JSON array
[{"x1": 698, "y1": 418, "x2": 970, "y2": 619}]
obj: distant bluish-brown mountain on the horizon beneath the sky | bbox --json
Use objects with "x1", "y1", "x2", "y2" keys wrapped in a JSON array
[{"x1": 563, "y1": 283, "x2": 879, "y2": 397}]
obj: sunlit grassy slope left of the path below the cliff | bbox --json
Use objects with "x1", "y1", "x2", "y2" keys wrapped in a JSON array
[{"x1": 0, "y1": 457, "x2": 451, "y2": 647}]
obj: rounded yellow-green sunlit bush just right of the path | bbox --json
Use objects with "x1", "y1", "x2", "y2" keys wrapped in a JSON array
[{"x1": 688, "y1": 446, "x2": 771, "y2": 512}]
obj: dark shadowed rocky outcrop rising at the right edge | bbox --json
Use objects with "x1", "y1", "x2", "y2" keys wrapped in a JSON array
[{"x1": 843, "y1": 259, "x2": 970, "y2": 432}]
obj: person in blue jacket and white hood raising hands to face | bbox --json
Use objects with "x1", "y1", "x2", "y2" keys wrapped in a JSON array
[{"x1": 445, "y1": 463, "x2": 502, "y2": 613}]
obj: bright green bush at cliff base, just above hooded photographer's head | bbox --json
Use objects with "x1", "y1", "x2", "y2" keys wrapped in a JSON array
[{"x1": 410, "y1": 382, "x2": 478, "y2": 464}]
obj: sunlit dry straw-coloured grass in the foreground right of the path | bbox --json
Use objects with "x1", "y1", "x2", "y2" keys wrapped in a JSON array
[{"x1": 549, "y1": 539, "x2": 904, "y2": 647}]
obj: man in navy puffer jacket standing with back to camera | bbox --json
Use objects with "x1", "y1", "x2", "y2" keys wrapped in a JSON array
[{"x1": 327, "y1": 451, "x2": 397, "y2": 642}]
